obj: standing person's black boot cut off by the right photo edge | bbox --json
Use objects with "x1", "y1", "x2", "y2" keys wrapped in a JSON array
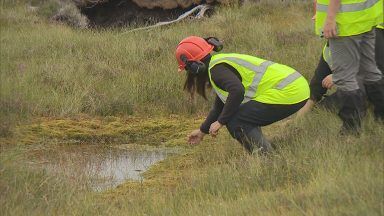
[{"x1": 364, "y1": 79, "x2": 384, "y2": 121}]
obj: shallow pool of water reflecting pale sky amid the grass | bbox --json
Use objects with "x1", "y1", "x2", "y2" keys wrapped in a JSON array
[{"x1": 31, "y1": 145, "x2": 175, "y2": 191}]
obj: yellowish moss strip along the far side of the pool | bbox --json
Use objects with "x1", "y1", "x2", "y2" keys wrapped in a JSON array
[{"x1": 2, "y1": 115, "x2": 202, "y2": 146}]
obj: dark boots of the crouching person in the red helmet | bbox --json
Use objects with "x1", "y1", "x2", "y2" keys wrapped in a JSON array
[{"x1": 238, "y1": 127, "x2": 272, "y2": 154}]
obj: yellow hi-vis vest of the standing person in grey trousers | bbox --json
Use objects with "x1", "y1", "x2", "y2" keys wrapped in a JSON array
[{"x1": 315, "y1": 0, "x2": 383, "y2": 36}]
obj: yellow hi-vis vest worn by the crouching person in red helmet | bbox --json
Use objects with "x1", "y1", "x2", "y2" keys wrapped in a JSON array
[{"x1": 208, "y1": 53, "x2": 309, "y2": 104}]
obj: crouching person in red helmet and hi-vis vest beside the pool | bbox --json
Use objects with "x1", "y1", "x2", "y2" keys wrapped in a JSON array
[{"x1": 176, "y1": 36, "x2": 309, "y2": 153}]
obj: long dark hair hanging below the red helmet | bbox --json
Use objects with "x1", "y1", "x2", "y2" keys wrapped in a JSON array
[{"x1": 184, "y1": 55, "x2": 211, "y2": 100}]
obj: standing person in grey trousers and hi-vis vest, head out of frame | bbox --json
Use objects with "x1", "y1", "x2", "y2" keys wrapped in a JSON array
[{"x1": 315, "y1": 0, "x2": 384, "y2": 134}]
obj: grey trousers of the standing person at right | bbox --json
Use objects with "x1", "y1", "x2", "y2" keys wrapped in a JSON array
[{"x1": 329, "y1": 30, "x2": 382, "y2": 91}]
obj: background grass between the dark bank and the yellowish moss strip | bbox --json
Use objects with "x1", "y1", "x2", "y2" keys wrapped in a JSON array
[{"x1": 0, "y1": 0, "x2": 321, "y2": 120}]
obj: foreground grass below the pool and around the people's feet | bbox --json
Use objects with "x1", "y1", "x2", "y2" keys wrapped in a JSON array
[{"x1": 0, "y1": 110, "x2": 384, "y2": 215}]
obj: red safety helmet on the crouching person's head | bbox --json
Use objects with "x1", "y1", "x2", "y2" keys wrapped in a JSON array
[{"x1": 176, "y1": 36, "x2": 214, "y2": 71}]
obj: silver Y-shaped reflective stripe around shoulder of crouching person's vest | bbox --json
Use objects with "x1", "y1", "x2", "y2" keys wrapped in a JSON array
[{"x1": 211, "y1": 57, "x2": 274, "y2": 103}]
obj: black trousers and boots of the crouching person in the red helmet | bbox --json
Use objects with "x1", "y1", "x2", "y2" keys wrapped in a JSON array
[{"x1": 227, "y1": 100, "x2": 307, "y2": 153}]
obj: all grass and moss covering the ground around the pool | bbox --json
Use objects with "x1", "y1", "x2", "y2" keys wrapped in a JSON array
[{"x1": 0, "y1": 0, "x2": 384, "y2": 215}]
